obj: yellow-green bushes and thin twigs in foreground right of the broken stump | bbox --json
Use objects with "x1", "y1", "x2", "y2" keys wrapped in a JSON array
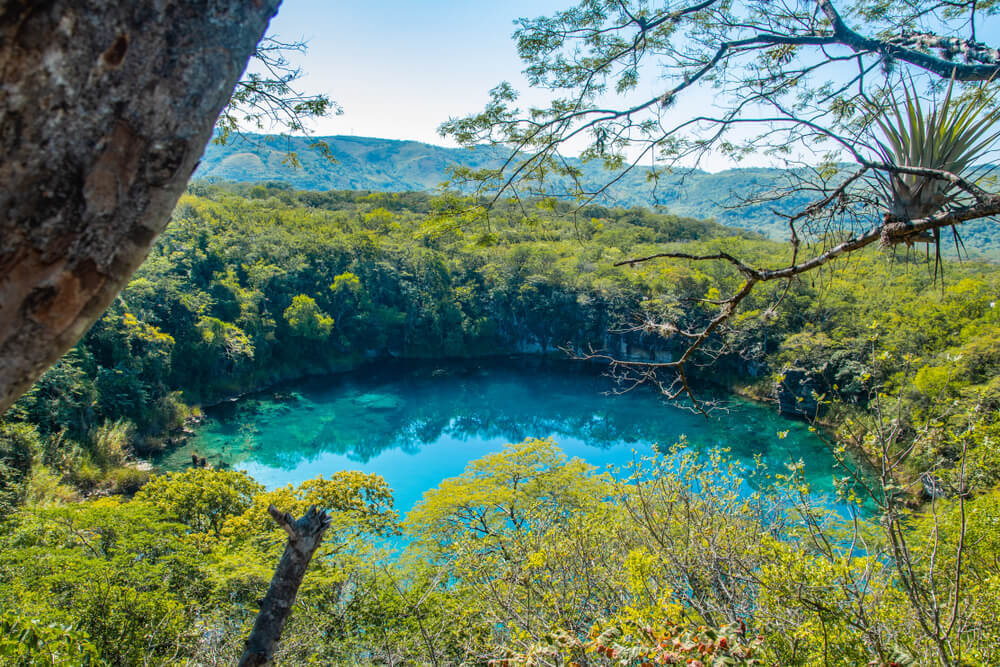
[{"x1": 374, "y1": 440, "x2": 995, "y2": 665}]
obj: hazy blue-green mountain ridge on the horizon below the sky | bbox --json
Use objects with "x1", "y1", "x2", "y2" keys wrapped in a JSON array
[{"x1": 194, "y1": 134, "x2": 1000, "y2": 257}]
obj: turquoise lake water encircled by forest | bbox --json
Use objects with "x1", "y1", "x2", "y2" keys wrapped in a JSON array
[{"x1": 160, "y1": 358, "x2": 848, "y2": 512}]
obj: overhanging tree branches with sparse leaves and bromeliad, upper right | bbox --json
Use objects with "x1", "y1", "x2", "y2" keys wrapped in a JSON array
[{"x1": 441, "y1": 0, "x2": 1000, "y2": 396}]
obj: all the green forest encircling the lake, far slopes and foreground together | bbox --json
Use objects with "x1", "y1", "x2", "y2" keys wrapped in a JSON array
[{"x1": 0, "y1": 184, "x2": 1000, "y2": 664}]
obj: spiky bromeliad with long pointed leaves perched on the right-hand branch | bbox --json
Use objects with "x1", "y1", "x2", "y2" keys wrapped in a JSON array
[{"x1": 875, "y1": 81, "x2": 1000, "y2": 220}]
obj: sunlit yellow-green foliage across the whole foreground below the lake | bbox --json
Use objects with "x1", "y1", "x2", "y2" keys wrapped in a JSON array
[{"x1": 0, "y1": 430, "x2": 998, "y2": 665}]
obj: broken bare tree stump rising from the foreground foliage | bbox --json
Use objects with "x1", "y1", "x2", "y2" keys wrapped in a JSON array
[{"x1": 239, "y1": 505, "x2": 330, "y2": 667}]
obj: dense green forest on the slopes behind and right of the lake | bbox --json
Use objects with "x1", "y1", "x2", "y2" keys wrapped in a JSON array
[{"x1": 6, "y1": 180, "x2": 1000, "y2": 495}]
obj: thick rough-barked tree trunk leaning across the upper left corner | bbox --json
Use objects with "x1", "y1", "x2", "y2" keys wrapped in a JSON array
[{"x1": 0, "y1": 0, "x2": 280, "y2": 414}]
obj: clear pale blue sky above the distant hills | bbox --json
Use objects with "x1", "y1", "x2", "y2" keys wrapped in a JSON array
[{"x1": 269, "y1": 0, "x2": 998, "y2": 171}]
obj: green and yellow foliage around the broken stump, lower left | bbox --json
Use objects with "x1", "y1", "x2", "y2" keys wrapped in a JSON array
[{"x1": 0, "y1": 469, "x2": 393, "y2": 666}]
